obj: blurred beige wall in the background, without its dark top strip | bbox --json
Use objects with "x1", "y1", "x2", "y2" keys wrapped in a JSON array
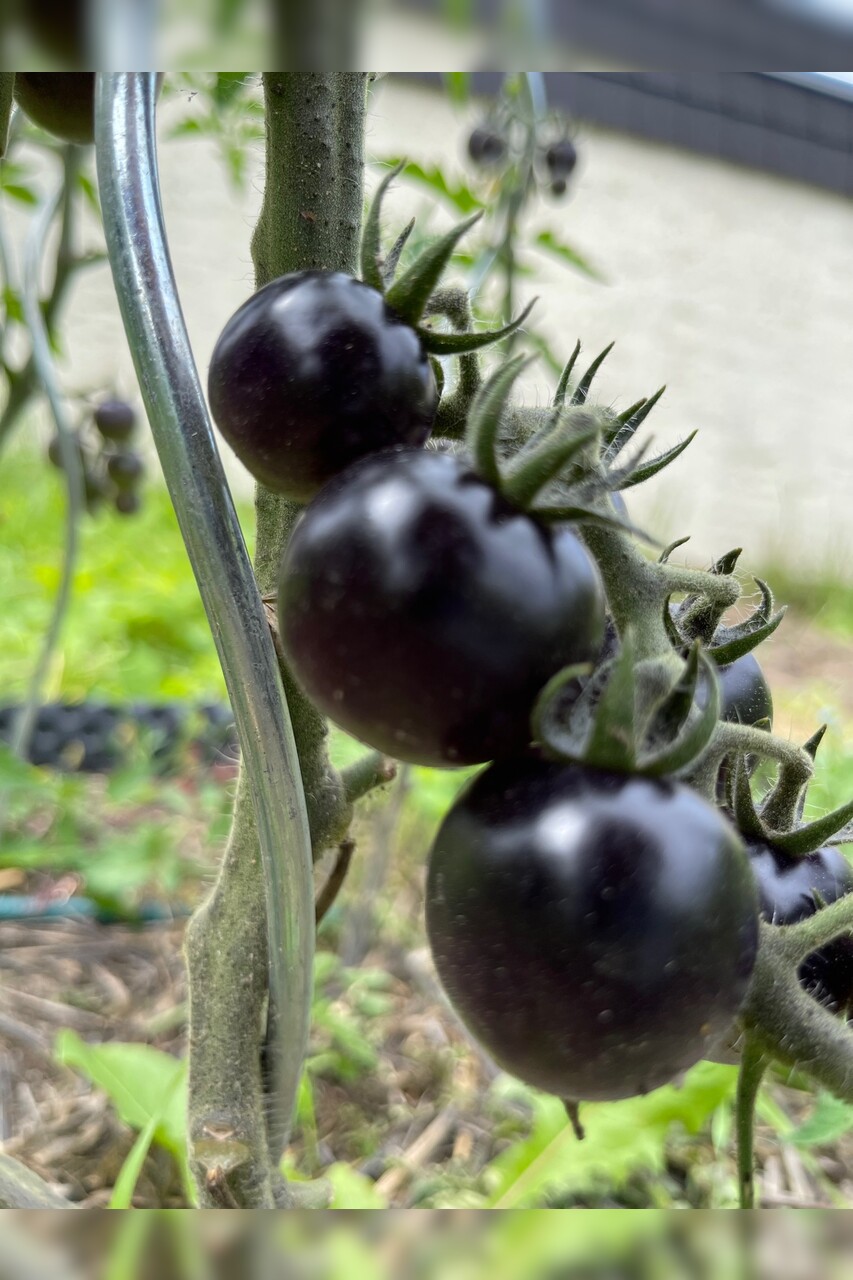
[{"x1": 11, "y1": 78, "x2": 853, "y2": 577}]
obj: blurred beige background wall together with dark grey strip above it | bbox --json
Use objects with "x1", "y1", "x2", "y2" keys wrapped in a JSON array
[{"x1": 9, "y1": 73, "x2": 853, "y2": 577}]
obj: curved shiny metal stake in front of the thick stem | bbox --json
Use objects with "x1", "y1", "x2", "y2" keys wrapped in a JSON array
[{"x1": 96, "y1": 72, "x2": 314, "y2": 1147}]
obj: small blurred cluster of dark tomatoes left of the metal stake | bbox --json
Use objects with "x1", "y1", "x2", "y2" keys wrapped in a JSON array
[{"x1": 47, "y1": 399, "x2": 145, "y2": 516}]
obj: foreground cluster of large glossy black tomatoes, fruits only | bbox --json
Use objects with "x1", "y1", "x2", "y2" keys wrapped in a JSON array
[{"x1": 209, "y1": 264, "x2": 853, "y2": 1100}]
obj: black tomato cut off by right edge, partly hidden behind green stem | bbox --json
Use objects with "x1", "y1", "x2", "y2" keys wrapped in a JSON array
[{"x1": 747, "y1": 841, "x2": 853, "y2": 1012}]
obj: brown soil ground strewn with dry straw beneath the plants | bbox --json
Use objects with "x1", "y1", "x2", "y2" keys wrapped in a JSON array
[{"x1": 0, "y1": 604, "x2": 853, "y2": 1207}]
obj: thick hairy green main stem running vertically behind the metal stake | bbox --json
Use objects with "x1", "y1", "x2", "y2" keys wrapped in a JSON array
[{"x1": 188, "y1": 73, "x2": 366, "y2": 1208}]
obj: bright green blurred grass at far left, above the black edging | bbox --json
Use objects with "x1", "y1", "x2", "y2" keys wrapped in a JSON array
[{"x1": 0, "y1": 449, "x2": 235, "y2": 701}]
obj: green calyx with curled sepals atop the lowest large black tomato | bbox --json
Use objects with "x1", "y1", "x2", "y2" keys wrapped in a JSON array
[{"x1": 533, "y1": 630, "x2": 720, "y2": 777}]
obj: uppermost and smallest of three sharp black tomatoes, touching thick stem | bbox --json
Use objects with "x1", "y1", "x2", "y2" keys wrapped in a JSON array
[{"x1": 209, "y1": 271, "x2": 438, "y2": 502}]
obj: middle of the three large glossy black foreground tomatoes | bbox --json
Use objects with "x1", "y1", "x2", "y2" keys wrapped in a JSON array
[{"x1": 278, "y1": 448, "x2": 605, "y2": 765}]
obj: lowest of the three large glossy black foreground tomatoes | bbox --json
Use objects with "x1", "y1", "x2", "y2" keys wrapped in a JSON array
[{"x1": 427, "y1": 756, "x2": 758, "y2": 1101}]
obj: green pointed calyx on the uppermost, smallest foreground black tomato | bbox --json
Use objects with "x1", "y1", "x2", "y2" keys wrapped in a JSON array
[{"x1": 360, "y1": 164, "x2": 534, "y2": 356}]
